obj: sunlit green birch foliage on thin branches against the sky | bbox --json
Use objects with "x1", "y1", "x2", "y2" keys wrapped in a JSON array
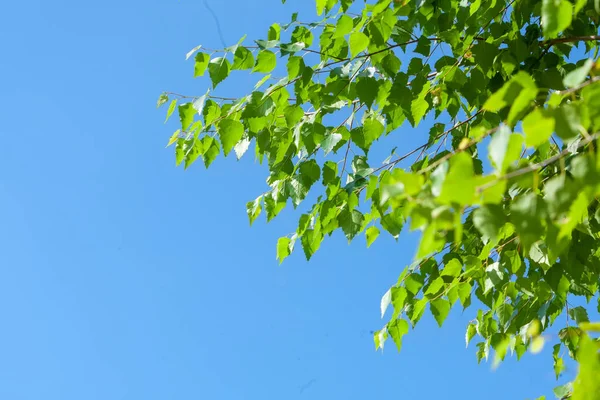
[{"x1": 158, "y1": 0, "x2": 600, "y2": 396}]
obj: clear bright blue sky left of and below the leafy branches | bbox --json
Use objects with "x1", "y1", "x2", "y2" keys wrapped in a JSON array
[{"x1": 0, "y1": 0, "x2": 576, "y2": 400}]
